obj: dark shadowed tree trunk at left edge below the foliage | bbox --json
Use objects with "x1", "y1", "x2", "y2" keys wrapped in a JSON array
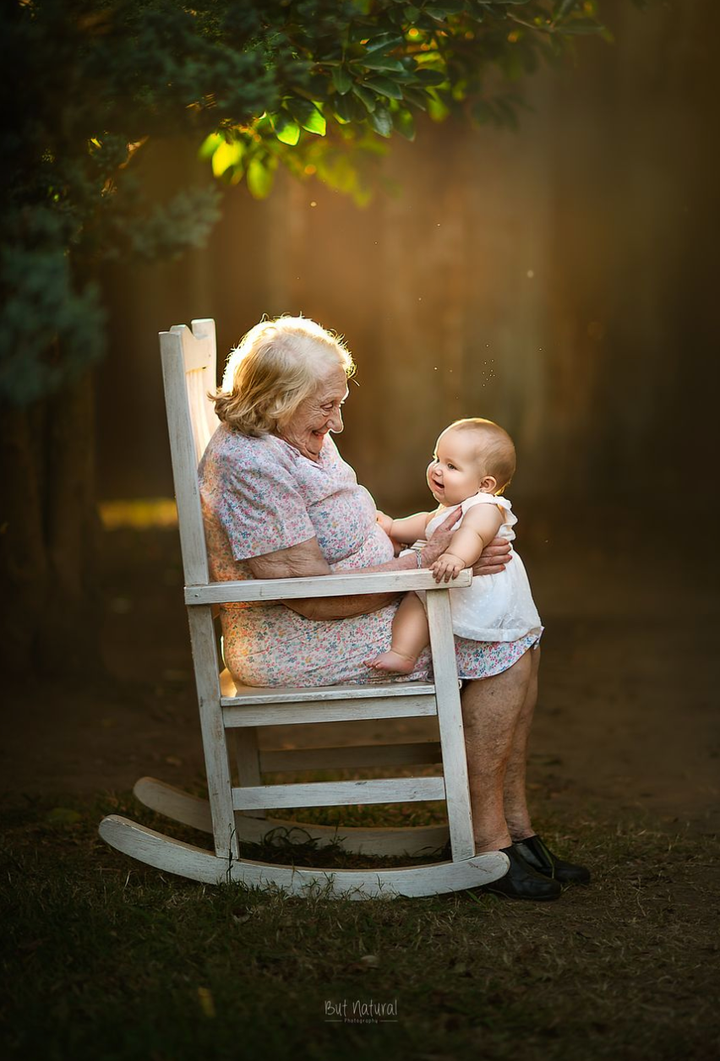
[{"x1": 0, "y1": 375, "x2": 102, "y2": 676}]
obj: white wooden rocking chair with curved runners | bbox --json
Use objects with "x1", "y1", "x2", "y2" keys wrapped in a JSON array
[{"x1": 100, "y1": 319, "x2": 509, "y2": 899}]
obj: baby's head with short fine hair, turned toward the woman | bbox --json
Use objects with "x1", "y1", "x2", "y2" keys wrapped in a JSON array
[{"x1": 427, "y1": 417, "x2": 515, "y2": 506}]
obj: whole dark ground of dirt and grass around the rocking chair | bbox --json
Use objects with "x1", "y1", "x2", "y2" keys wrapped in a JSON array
[{"x1": 0, "y1": 498, "x2": 720, "y2": 1061}]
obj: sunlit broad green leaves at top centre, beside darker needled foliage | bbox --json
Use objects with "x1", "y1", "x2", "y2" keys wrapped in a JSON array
[{"x1": 201, "y1": 0, "x2": 610, "y2": 205}]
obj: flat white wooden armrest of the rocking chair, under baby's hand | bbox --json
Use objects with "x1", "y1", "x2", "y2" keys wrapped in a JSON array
[{"x1": 185, "y1": 570, "x2": 473, "y2": 605}]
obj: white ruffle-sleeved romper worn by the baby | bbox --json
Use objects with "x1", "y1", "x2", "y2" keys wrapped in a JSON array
[{"x1": 425, "y1": 493, "x2": 543, "y2": 641}]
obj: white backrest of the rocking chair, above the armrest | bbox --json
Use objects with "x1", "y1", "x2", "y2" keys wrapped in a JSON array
[{"x1": 160, "y1": 318, "x2": 219, "y2": 586}]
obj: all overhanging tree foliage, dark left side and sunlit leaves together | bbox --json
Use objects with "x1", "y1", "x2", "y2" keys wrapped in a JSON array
[{"x1": 0, "y1": 0, "x2": 623, "y2": 404}]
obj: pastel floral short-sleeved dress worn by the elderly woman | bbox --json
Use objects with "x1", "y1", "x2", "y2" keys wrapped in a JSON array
[{"x1": 199, "y1": 424, "x2": 537, "y2": 685}]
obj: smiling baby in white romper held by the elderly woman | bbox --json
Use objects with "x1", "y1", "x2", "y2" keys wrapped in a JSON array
[{"x1": 370, "y1": 417, "x2": 542, "y2": 674}]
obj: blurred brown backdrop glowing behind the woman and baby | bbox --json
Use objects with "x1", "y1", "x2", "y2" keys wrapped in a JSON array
[{"x1": 98, "y1": 0, "x2": 720, "y2": 509}]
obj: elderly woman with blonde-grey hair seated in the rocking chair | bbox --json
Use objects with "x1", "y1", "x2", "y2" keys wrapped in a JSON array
[{"x1": 199, "y1": 317, "x2": 589, "y2": 899}]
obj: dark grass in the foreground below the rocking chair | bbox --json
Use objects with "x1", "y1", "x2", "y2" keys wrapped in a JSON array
[{"x1": 0, "y1": 797, "x2": 720, "y2": 1061}]
